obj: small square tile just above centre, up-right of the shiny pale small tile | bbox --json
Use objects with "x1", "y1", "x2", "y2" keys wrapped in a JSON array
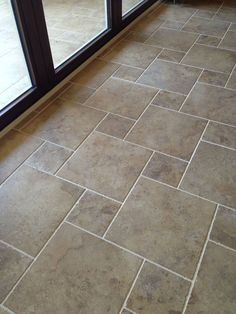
[{"x1": 97, "y1": 114, "x2": 135, "y2": 139}]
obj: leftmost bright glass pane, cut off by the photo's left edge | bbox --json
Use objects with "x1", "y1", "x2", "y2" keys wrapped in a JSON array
[{"x1": 0, "y1": 0, "x2": 32, "y2": 110}]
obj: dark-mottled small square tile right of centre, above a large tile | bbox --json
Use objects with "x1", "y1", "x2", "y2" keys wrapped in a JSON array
[{"x1": 143, "y1": 153, "x2": 187, "y2": 186}]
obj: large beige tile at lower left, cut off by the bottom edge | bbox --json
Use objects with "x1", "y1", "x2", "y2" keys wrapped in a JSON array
[{"x1": 6, "y1": 224, "x2": 141, "y2": 314}]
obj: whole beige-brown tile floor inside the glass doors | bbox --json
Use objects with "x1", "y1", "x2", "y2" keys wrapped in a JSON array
[{"x1": 0, "y1": 0, "x2": 236, "y2": 314}]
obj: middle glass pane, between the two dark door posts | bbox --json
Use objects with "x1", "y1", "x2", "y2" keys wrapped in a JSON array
[{"x1": 43, "y1": 0, "x2": 107, "y2": 67}]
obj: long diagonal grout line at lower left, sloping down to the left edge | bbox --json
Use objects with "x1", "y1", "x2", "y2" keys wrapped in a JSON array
[{"x1": 2, "y1": 190, "x2": 86, "y2": 304}]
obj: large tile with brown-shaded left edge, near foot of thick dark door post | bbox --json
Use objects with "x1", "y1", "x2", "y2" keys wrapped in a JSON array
[{"x1": 24, "y1": 99, "x2": 105, "y2": 149}]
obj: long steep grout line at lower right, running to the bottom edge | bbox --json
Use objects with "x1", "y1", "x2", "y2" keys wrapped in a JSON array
[{"x1": 182, "y1": 205, "x2": 218, "y2": 314}]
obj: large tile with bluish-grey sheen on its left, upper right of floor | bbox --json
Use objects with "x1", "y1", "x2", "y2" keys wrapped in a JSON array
[{"x1": 138, "y1": 60, "x2": 201, "y2": 95}]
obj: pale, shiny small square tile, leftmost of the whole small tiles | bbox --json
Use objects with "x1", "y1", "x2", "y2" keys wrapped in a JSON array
[{"x1": 26, "y1": 143, "x2": 73, "y2": 174}]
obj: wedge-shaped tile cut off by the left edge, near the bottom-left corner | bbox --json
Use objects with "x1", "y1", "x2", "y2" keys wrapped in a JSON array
[{"x1": 0, "y1": 241, "x2": 32, "y2": 302}]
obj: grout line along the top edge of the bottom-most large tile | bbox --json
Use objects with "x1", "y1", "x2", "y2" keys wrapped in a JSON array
[{"x1": 65, "y1": 220, "x2": 192, "y2": 282}]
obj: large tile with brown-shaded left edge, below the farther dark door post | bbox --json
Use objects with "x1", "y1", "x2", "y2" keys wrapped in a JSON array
[{"x1": 100, "y1": 40, "x2": 161, "y2": 69}]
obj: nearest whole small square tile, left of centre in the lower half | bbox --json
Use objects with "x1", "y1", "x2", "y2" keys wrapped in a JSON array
[{"x1": 67, "y1": 191, "x2": 121, "y2": 236}]
